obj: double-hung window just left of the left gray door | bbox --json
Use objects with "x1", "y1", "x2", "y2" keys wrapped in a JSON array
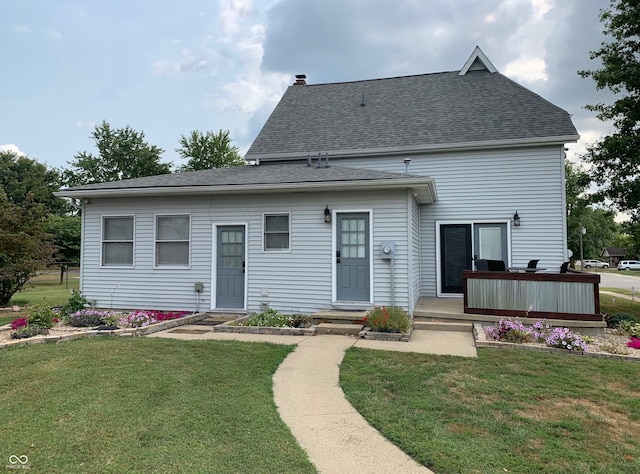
[{"x1": 156, "y1": 214, "x2": 191, "y2": 267}]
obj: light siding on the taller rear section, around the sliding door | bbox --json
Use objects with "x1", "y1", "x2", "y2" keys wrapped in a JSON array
[{"x1": 332, "y1": 145, "x2": 567, "y2": 296}]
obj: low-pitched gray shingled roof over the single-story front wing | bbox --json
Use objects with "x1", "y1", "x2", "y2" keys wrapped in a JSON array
[{"x1": 56, "y1": 162, "x2": 435, "y2": 201}]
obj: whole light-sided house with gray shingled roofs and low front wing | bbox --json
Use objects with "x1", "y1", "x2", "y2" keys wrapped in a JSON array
[{"x1": 59, "y1": 48, "x2": 578, "y2": 313}]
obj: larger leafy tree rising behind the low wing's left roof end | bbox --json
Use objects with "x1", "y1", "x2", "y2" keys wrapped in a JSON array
[{"x1": 64, "y1": 121, "x2": 171, "y2": 186}]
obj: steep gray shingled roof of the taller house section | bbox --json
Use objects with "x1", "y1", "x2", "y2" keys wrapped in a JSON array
[{"x1": 246, "y1": 70, "x2": 578, "y2": 160}]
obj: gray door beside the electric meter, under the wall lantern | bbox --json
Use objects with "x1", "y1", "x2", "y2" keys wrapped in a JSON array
[{"x1": 336, "y1": 213, "x2": 370, "y2": 301}]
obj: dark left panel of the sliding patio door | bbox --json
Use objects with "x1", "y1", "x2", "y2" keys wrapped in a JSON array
[{"x1": 440, "y1": 224, "x2": 472, "y2": 293}]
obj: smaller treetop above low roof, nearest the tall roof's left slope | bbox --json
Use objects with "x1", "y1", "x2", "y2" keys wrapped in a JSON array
[{"x1": 176, "y1": 130, "x2": 245, "y2": 171}]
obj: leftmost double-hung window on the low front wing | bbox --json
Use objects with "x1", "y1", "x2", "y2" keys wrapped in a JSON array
[{"x1": 102, "y1": 216, "x2": 133, "y2": 267}]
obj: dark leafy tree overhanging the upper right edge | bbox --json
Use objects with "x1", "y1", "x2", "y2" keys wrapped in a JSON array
[{"x1": 578, "y1": 0, "x2": 640, "y2": 222}]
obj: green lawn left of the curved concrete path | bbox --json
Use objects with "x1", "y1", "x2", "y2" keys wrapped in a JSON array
[{"x1": 0, "y1": 337, "x2": 315, "y2": 473}]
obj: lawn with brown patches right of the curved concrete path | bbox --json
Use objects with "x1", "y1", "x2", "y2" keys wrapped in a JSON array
[{"x1": 340, "y1": 348, "x2": 640, "y2": 474}]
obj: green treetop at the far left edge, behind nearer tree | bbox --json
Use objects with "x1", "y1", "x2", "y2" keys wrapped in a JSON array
[{"x1": 0, "y1": 151, "x2": 70, "y2": 214}]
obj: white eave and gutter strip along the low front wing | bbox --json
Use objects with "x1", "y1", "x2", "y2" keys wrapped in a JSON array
[{"x1": 54, "y1": 177, "x2": 437, "y2": 204}]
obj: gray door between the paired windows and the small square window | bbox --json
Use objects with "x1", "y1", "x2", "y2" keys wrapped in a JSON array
[{"x1": 216, "y1": 225, "x2": 245, "y2": 309}]
